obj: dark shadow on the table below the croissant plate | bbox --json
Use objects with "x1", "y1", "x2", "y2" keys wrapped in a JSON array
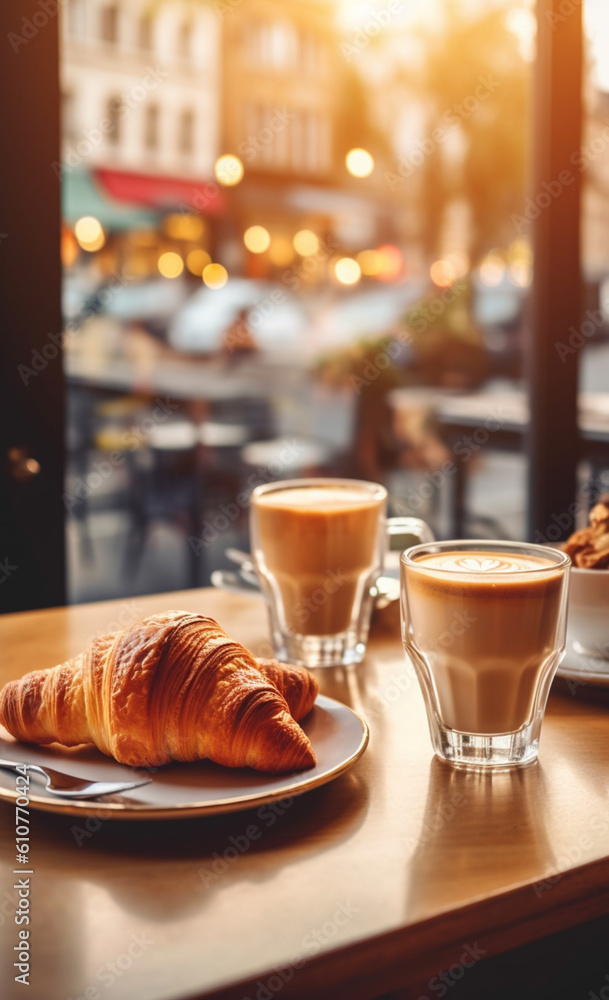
[{"x1": 0, "y1": 760, "x2": 369, "y2": 922}]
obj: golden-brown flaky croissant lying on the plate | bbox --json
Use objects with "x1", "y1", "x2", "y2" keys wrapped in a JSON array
[{"x1": 0, "y1": 611, "x2": 319, "y2": 773}]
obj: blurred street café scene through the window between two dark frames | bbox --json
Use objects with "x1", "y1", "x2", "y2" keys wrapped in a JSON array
[{"x1": 61, "y1": 0, "x2": 536, "y2": 600}]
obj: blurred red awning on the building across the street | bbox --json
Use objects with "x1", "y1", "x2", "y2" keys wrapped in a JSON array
[{"x1": 95, "y1": 167, "x2": 226, "y2": 215}]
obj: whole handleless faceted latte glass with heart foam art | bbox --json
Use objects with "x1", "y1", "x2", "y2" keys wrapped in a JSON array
[{"x1": 401, "y1": 541, "x2": 570, "y2": 768}]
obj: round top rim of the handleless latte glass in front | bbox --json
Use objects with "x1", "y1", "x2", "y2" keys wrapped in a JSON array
[{"x1": 400, "y1": 538, "x2": 571, "y2": 579}]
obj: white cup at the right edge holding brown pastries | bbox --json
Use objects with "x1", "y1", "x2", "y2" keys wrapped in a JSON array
[{"x1": 567, "y1": 566, "x2": 609, "y2": 661}]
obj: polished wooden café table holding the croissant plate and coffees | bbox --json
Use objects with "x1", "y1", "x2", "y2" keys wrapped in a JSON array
[{"x1": 0, "y1": 590, "x2": 609, "y2": 1000}]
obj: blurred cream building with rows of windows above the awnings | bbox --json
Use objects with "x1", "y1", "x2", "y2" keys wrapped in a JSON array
[{"x1": 62, "y1": 0, "x2": 221, "y2": 178}]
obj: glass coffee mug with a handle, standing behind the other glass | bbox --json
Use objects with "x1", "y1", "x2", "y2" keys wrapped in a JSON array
[{"x1": 250, "y1": 479, "x2": 433, "y2": 667}]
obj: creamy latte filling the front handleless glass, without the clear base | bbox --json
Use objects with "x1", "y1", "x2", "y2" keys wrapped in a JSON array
[{"x1": 403, "y1": 549, "x2": 564, "y2": 735}]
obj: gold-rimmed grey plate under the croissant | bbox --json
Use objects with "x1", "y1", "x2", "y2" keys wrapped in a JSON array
[{"x1": 0, "y1": 695, "x2": 368, "y2": 820}]
